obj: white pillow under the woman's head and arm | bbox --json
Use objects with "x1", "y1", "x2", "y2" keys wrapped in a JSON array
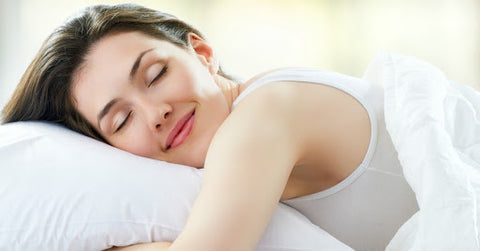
[{"x1": 0, "y1": 122, "x2": 350, "y2": 250}]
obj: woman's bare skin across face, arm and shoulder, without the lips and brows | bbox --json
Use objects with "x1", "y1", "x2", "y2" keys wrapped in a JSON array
[{"x1": 73, "y1": 32, "x2": 370, "y2": 250}]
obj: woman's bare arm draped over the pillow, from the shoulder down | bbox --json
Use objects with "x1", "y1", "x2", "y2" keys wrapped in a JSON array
[{"x1": 171, "y1": 83, "x2": 300, "y2": 250}]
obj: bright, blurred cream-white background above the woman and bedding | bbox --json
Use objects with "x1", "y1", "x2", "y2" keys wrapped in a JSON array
[{"x1": 0, "y1": 0, "x2": 480, "y2": 115}]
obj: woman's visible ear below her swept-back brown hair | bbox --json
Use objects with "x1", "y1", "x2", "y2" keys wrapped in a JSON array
[{"x1": 187, "y1": 32, "x2": 219, "y2": 75}]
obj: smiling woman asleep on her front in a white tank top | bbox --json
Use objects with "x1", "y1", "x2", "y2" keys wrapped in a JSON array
[{"x1": 3, "y1": 5, "x2": 417, "y2": 250}]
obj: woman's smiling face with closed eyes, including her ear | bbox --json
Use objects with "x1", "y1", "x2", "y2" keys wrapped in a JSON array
[{"x1": 73, "y1": 32, "x2": 230, "y2": 167}]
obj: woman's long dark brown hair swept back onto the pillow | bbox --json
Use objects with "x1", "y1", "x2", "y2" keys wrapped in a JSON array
[{"x1": 2, "y1": 4, "x2": 230, "y2": 141}]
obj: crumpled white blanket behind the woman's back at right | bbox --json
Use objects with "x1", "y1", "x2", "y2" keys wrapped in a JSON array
[{"x1": 368, "y1": 53, "x2": 480, "y2": 250}]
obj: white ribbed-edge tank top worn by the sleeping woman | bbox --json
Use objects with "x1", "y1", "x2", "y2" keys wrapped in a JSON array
[{"x1": 233, "y1": 68, "x2": 418, "y2": 251}]
